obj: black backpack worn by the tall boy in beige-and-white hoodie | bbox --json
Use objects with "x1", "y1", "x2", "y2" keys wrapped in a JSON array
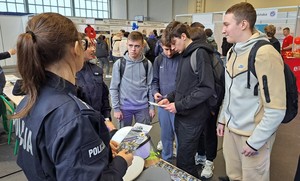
[{"x1": 247, "y1": 40, "x2": 298, "y2": 123}]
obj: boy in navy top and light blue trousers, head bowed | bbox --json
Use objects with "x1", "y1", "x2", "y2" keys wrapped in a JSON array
[{"x1": 151, "y1": 31, "x2": 181, "y2": 162}]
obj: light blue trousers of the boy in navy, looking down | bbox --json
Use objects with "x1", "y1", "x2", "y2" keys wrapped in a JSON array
[{"x1": 158, "y1": 107, "x2": 176, "y2": 162}]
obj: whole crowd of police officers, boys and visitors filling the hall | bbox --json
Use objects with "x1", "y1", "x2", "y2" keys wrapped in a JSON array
[{"x1": 0, "y1": 2, "x2": 293, "y2": 181}]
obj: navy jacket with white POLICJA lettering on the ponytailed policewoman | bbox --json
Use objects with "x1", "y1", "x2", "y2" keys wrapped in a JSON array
[{"x1": 16, "y1": 72, "x2": 127, "y2": 181}]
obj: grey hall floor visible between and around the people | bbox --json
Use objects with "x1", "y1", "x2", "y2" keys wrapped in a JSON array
[{"x1": 0, "y1": 67, "x2": 300, "y2": 181}]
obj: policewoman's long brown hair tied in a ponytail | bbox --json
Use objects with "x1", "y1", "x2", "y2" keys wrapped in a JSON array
[{"x1": 13, "y1": 13, "x2": 79, "y2": 118}]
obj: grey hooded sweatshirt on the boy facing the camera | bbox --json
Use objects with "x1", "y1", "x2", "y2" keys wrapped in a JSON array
[{"x1": 109, "y1": 53, "x2": 154, "y2": 112}]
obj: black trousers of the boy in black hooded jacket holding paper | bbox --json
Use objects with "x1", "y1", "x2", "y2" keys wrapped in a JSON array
[{"x1": 175, "y1": 116, "x2": 207, "y2": 178}]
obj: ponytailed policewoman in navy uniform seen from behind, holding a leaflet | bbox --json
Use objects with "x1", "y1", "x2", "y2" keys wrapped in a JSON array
[{"x1": 14, "y1": 13, "x2": 133, "y2": 181}]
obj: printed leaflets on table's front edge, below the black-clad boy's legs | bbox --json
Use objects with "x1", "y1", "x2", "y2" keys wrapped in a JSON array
[{"x1": 155, "y1": 159, "x2": 200, "y2": 181}]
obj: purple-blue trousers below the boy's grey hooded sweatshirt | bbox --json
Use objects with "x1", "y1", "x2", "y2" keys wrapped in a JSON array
[{"x1": 119, "y1": 108, "x2": 151, "y2": 128}]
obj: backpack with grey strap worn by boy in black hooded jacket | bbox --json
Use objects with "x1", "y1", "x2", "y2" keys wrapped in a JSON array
[{"x1": 190, "y1": 47, "x2": 225, "y2": 113}]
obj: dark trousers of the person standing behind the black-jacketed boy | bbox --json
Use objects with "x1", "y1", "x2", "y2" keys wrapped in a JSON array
[{"x1": 198, "y1": 110, "x2": 218, "y2": 161}]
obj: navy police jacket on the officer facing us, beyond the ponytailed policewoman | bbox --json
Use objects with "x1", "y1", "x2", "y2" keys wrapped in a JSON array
[{"x1": 76, "y1": 62, "x2": 111, "y2": 118}]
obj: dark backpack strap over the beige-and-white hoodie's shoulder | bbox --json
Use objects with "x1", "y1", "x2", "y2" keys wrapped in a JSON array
[{"x1": 247, "y1": 40, "x2": 270, "y2": 88}]
